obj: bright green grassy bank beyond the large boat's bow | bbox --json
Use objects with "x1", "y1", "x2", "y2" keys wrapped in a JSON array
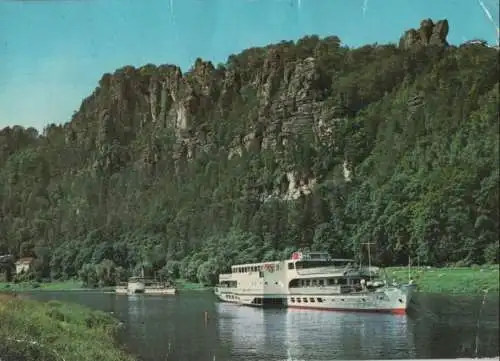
[{"x1": 385, "y1": 265, "x2": 499, "y2": 294}]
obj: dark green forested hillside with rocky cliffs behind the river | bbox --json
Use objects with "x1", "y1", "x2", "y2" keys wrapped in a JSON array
[{"x1": 0, "y1": 20, "x2": 500, "y2": 284}]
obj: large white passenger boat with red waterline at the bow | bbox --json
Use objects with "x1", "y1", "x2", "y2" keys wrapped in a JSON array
[{"x1": 215, "y1": 252, "x2": 415, "y2": 314}]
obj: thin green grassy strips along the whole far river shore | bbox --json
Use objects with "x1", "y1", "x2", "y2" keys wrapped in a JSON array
[{"x1": 0, "y1": 265, "x2": 499, "y2": 295}]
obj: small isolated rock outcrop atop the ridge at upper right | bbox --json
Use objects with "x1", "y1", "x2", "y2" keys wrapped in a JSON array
[{"x1": 399, "y1": 19, "x2": 449, "y2": 49}]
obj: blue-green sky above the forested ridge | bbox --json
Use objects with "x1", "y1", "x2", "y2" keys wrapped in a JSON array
[{"x1": 0, "y1": 0, "x2": 498, "y2": 130}]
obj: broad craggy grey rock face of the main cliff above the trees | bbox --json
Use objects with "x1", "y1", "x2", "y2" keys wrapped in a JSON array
[{"x1": 65, "y1": 38, "x2": 348, "y2": 199}]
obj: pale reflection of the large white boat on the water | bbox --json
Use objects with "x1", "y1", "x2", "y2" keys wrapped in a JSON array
[{"x1": 217, "y1": 303, "x2": 416, "y2": 361}]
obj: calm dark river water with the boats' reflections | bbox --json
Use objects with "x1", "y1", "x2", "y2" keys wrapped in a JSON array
[{"x1": 30, "y1": 291, "x2": 499, "y2": 361}]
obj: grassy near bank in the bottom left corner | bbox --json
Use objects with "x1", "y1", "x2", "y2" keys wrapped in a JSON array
[{"x1": 0, "y1": 293, "x2": 133, "y2": 361}]
